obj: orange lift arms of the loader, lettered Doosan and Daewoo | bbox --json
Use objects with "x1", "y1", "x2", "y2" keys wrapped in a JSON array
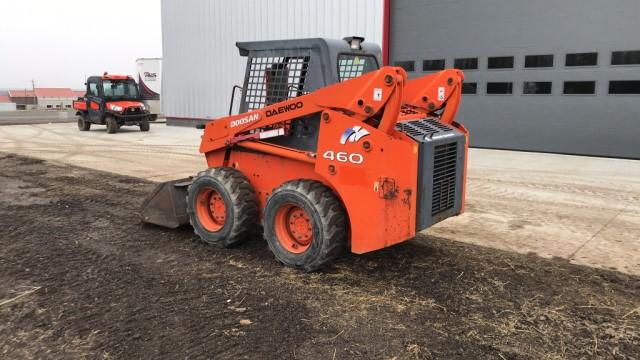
[{"x1": 200, "y1": 66, "x2": 463, "y2": 161}]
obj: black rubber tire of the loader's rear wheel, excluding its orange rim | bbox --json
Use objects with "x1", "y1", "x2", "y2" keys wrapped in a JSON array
[{"x1": 264, "y1": 179, "x2": 348, "y2": 272}]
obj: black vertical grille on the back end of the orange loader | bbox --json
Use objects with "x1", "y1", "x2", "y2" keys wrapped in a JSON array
[{"x1": 431, "y1": 143, "x2": 458, "y2": 216}]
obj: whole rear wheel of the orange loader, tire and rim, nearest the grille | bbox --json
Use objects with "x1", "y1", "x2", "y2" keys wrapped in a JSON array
[{"x1": 264, "y1": 180, "x2": 348, "y2": 272}]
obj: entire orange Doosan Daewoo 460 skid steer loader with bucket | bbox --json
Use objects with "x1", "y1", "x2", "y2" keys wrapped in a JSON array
[{"x1": 142, "y1": 37, "x2": 468, "y2": 271}]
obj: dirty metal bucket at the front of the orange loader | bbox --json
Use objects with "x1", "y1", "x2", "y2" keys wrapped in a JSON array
[{"x1": 140, "y1": 178, "x2": 191, "y2": 229}]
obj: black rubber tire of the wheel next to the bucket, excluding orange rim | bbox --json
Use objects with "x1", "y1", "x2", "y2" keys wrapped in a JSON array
[{"x1": 187, "y1": 167, "x2": 258, "y2": 248}]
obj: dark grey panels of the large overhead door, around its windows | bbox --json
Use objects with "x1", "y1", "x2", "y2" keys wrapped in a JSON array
[{"x1": 390, "y1": 0, "x2": 640, "y2": 158}]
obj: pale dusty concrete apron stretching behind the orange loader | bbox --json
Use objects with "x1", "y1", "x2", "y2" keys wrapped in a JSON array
[{"x1": 0, "y1": 123, "x2": 640, "y2": 275}]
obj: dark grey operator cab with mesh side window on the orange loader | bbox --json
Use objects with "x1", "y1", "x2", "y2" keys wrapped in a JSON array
[{"x1": 229, "y1": 36, "x2": 382, "y2": 115}]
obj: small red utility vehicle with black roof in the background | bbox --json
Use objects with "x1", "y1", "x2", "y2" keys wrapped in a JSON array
[{"x1": 73, "y1": 73, "x2": 156, "y2": 134}]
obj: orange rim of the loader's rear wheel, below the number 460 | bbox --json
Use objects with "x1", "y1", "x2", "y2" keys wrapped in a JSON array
[{"x1": 275, "y1": 204, "x2": 313, "y2": 254}]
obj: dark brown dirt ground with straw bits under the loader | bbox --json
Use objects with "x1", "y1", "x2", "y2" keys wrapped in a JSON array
[{"x1": 0, "y1": 153, "x2": 640, "y2": 359}]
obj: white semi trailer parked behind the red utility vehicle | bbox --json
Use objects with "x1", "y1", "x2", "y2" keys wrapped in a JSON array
[{"x1": 136, "y1": 58, "x2": 162, "y2": 114}]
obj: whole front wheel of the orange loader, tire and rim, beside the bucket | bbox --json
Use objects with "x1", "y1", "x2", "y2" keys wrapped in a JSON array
[{"x1": 187, "y1": 167, "x2": 258, "y2": 247}]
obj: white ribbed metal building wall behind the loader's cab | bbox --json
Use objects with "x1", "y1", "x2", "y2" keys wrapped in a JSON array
[{"x1": 162, "y1": 0, "x2": 384, "y2": 124}]
